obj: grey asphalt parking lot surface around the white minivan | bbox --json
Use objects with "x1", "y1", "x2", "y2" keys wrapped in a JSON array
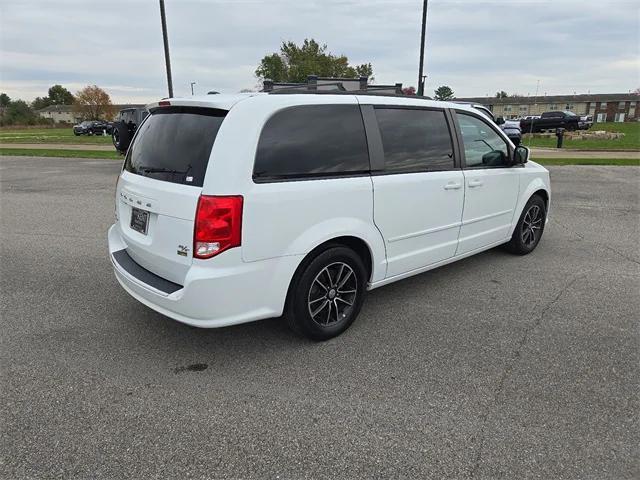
[{"x1": 0, "y1": 157, "x2": 640, "y2": 479}]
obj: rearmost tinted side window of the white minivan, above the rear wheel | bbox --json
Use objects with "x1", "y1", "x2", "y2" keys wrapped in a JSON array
[{"x1": 253, "y1": 105, "x2": 369, "y2": 181}]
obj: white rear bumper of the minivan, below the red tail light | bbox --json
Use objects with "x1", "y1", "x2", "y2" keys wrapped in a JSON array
[{"x1": 108, "y1": 224, "x2": 302, "y2": 328}]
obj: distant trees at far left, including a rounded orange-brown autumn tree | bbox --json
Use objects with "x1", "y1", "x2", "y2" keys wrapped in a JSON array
[{"x1": 0, "y1": 84, "x2": 116, "y2": 126}]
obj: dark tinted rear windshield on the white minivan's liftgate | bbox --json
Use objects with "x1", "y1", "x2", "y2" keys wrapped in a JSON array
[{"x1": 124, "y1": 107, "x2": 227, "y2": 187}]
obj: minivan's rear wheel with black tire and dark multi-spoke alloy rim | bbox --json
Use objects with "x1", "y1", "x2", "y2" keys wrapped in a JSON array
[{"x1": 285, "y1": 245, "x2": 367, "y2": 341}]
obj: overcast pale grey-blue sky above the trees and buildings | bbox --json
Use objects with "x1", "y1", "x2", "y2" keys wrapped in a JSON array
[{"x1": 0, "y1": 0, "x2": 640, "y2": 103}]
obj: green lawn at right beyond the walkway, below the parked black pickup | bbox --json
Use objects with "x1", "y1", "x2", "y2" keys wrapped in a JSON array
[{"x1": 522, "y1": 122, "x2": 640, "y2": 151}]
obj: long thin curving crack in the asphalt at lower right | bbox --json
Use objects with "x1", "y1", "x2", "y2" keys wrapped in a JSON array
[{"x1": 469, "y1": 272, "x2": 588, "y2": 478}]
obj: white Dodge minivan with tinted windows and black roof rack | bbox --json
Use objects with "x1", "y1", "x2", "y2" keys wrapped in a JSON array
[{"x1": 108, "y1": 89, "x2": 550, "y2": 340}]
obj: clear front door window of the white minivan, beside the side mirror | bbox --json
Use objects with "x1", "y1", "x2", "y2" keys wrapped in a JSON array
[{"x1": 458, "y1": 112, "x2": 509, "y2": 167}]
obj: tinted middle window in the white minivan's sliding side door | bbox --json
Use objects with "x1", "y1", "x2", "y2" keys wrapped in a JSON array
[{"x1": 375, "y1": 108, "x2": 453, "y2": 172}]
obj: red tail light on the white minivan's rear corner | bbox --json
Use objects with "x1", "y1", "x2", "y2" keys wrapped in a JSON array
[{"x1": 193, "y1": 195, "x2": 242, "y2": 258}]
